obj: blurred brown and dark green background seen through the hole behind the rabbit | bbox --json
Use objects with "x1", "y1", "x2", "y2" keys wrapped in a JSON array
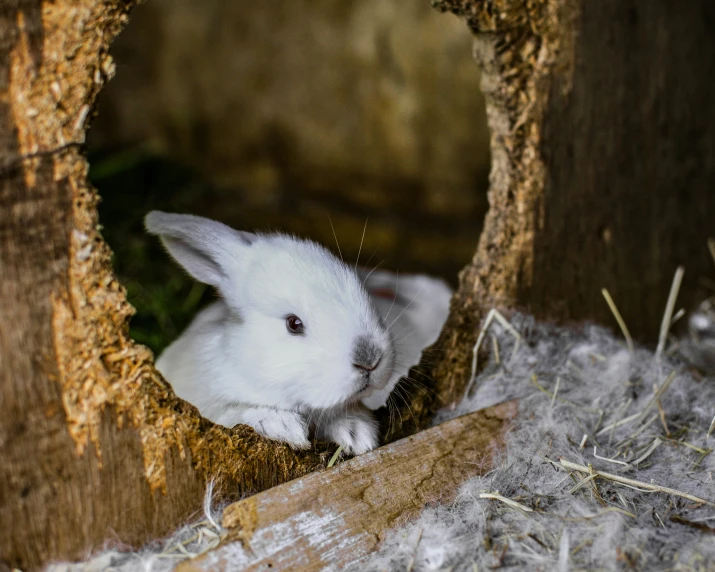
[{"x1": 89, "y1": 0, "x2": 490, "y2": 352}]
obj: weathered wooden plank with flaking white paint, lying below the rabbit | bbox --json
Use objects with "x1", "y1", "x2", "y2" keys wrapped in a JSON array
[{"x1": 177, "y1": 401, "x2": 517, "y2": 572}]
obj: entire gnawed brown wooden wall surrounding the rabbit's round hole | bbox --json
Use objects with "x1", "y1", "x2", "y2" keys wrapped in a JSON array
[{"x1": 0, "y1": 0, "x2": 715, "y2": 569}]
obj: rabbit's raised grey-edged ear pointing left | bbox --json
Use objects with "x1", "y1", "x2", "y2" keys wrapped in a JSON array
[{"x1": 144, "y1": 211, "x2": 256, "y2": 298}]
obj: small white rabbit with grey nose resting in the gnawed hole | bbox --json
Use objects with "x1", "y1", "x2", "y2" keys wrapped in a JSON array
[{"x1": 145, "y1": 211, "x2": 454, "y2": 454}]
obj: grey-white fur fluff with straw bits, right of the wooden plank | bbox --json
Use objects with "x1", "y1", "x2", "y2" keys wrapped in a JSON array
[{"x1": 355, "y1": 316, "x2": 715, "y2": 571}]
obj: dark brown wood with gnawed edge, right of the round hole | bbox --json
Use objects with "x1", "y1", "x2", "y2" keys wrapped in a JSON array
[{"x1": 396, "y1": 0, "x2": 715, "y2": 434}]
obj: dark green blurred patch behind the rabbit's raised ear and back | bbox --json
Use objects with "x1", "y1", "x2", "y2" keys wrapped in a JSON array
[{"x1": 90, "y1": 149, "x2": 215, "y2": 353}]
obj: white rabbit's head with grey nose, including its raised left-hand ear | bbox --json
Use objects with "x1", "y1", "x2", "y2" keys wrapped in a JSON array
[{"x1": 145, "y1": 211, "x2": 395, "y2": 410}]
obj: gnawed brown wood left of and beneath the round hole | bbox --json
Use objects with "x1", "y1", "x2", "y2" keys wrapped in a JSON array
[{"x1": 0, "y1": 0, "x2": 323, "y2": 569}]
